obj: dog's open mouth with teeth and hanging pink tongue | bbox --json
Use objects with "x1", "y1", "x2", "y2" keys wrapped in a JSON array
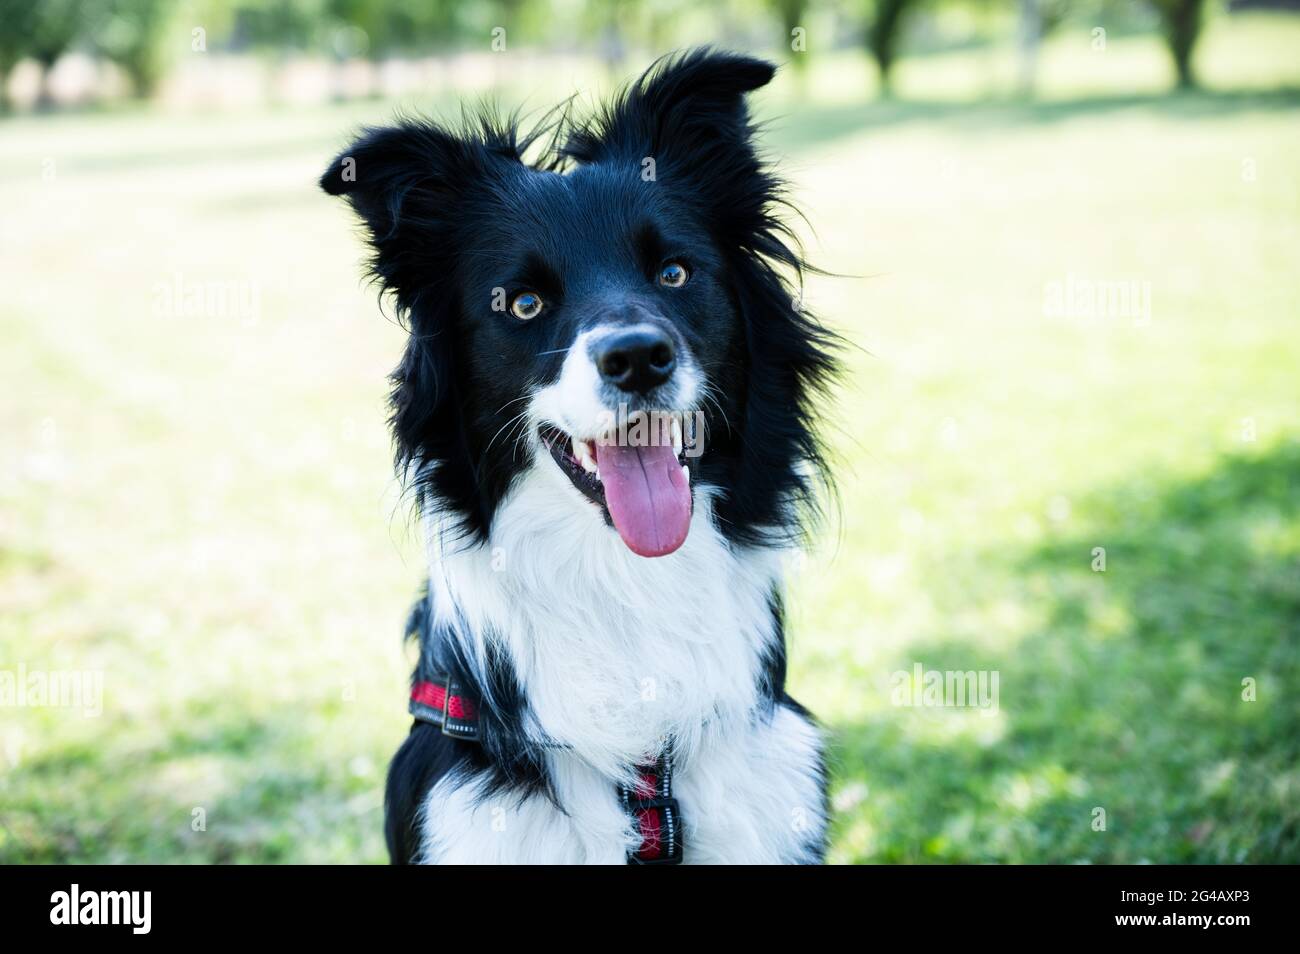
[{"x1": 538, "y1": 416, "x2": 693, "y2": 556}]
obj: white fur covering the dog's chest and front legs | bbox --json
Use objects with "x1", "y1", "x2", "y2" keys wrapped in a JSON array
[{"x1": 424, "y1": 468, "x2": 824, "y2": 863}]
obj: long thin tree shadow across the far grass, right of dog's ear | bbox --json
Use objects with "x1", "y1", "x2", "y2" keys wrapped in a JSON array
[{"x1": 768, "y1": 87, "x2": 1300, "y2": 152}]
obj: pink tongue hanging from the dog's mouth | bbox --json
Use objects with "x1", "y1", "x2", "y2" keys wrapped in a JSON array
[{"x1": 595, "y1": 441, "x2": 690, "y2": 556}]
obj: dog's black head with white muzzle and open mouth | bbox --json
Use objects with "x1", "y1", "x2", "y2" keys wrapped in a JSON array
[{"x1": 321, "y1": 51, "x2": 833, "y2": 556}]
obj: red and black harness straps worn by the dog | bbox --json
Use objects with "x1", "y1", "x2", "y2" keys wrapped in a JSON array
[{"x1": 410, "y1": 673, "x2": 681, "y2": 864}]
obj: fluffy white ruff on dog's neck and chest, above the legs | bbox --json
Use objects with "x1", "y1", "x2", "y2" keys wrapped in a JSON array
[{"x1": 424, "y1": 469, "x2": 784, "y2": 775}]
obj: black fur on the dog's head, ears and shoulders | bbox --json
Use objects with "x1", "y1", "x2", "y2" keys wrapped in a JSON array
[{"x1": 320, "y1": 49, "x2": 837, "y2": 863}]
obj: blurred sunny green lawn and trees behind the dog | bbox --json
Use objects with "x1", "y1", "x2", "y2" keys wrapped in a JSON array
[{"x1": 0, "y1": 0, "x2": 1300, "y2": 863}]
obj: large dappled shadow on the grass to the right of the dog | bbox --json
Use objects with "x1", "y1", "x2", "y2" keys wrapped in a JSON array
[{"x1": 836, "y1": 443, "x2": 1300, "y2": 863}]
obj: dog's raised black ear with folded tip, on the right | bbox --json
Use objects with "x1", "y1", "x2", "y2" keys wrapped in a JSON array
[{"x1": 564, "y1": 47, "x2": 776, "y2": 165}]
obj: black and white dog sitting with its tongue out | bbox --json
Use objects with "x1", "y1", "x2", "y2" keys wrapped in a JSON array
[{"x1": 320, "y1": 48, "x2": 839, "y2": 864}]
